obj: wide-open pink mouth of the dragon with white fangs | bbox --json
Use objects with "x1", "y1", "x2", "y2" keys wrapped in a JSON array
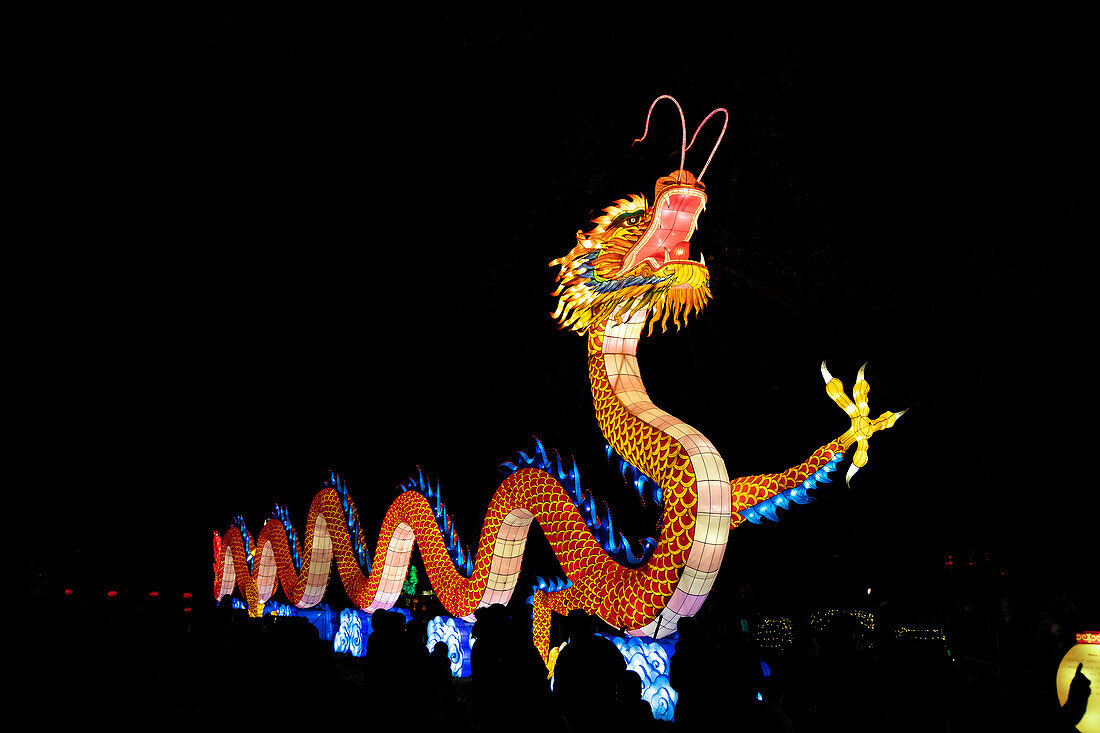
[{"x1": 617, "y1": 186, "x2": 706, "y2": 280}]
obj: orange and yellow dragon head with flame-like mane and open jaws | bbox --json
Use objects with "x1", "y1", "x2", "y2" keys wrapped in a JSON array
[{"x1": 550, "y1": 169, "x2": 711, "y2": 333}]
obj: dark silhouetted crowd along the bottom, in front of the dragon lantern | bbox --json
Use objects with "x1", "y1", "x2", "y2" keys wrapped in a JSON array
[{"x1": 14, "y1": 559, "x2": 1090, "y2": 733}]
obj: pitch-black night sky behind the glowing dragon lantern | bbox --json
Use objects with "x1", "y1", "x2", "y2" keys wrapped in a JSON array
[{"x1": 2, "y1": 3, "x2": 1098, "y2": 606}]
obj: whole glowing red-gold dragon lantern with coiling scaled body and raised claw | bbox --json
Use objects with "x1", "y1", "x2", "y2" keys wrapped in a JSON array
[{"x1": 213, "y1": 96, "x2": 900, "y2": 659}]
